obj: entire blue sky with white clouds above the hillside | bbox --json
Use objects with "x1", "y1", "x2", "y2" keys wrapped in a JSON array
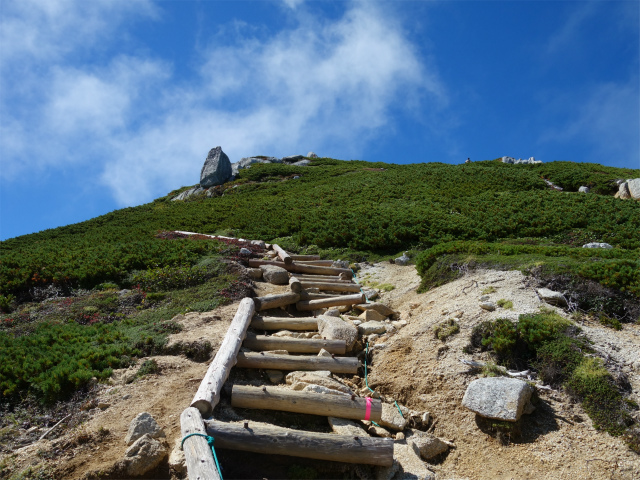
[{"x1": 0, "y1": 0, "x2": 640, "y2": 239}]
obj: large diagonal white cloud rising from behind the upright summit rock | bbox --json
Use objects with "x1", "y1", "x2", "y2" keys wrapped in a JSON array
[{"x1": 103, "y1": 1, "x2": 446, "y2": 204}]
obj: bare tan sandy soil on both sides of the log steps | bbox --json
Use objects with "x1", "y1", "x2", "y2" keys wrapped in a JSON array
[{"x1": 6, "y1": 263, "x2": 640, "y2": 480}]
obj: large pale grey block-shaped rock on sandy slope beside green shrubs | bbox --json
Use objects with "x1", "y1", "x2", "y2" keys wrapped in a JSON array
[{"x1": 464, "y1": 377, "x2": 533, "y2": 422}]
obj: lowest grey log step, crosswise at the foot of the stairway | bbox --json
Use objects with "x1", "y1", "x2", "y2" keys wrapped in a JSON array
[{"x1": 206, "y1": 420, "x2": 393, "y2": 466}]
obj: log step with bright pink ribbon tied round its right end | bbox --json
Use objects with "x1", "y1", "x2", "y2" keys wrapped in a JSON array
[{"x1": 231, "y1": 385, "x2": 382, "y2": 422}]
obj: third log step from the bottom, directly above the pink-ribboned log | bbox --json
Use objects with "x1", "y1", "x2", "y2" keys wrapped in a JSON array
[{"x1": 236, "y1": 352, "x2": 360, "y2": 373}]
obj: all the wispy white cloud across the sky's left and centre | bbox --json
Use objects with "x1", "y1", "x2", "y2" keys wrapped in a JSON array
[{"x1": 0, "y1": 0, "x2": 447, "y2": 205}]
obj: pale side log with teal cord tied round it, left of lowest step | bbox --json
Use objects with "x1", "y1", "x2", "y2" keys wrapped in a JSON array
[{"x1": 180, "y1": 407, "x2": 220, "y2": 480}]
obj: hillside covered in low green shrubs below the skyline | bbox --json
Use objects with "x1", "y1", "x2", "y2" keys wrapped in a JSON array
[{"x1": 0, "y1": 158, "x2": 640, "y2": 404}]
